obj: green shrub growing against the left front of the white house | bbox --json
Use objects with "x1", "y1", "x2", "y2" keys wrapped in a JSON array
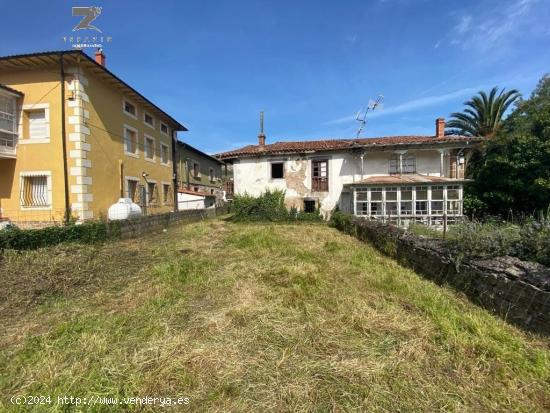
[{"x1": 231, "y1": 190, "x2": 289, "y2": 222}]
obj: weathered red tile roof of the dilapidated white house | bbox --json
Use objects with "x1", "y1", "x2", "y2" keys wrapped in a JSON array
[{"x1": 216, "y1": 135, "x2": 482, "y2": 160}]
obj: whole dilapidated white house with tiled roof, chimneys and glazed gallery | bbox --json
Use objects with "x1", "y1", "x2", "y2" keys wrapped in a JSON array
[{"x1": 218, "y1": 118, "x2": 482, "y2": 225}]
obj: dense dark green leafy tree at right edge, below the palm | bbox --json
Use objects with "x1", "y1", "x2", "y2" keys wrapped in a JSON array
[{"x1": 467, "y1": 75, "x2": 550, "y2": 217}]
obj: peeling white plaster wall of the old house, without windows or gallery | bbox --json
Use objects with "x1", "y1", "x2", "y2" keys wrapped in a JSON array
[{"x1": 233, "y1": 150, "x2": 452, "y2": 215}]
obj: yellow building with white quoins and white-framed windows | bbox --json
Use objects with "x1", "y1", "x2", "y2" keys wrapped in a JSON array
[{"x1": 0, "y1": 50, "x2": 187, "y2": 224}]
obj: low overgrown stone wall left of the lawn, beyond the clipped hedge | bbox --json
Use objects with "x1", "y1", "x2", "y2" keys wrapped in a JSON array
[{"x1": 109, "y1": 206, "x2": 228, "y2": 238}]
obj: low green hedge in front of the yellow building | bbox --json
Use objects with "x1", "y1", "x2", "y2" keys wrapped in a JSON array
[{"x1": 0, "y1": 222, "x2": 109, "y2": 250}]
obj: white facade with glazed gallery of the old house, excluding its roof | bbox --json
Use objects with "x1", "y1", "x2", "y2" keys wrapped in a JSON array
[{"x1": 233, "y1": 145, "x2": 470, "y2": 224}]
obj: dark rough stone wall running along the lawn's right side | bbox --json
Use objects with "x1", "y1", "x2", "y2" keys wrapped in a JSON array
[{"x1": 353, "y1": 218, "x2": 550, "y2": 334}]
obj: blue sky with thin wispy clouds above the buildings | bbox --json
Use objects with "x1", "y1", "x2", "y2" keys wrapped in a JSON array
[{"x1": 0, "y1": 0, "x2": 550, "y2": 153}]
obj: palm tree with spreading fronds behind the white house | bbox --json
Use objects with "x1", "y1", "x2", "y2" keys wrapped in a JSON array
[{"x1": 447, "y1": 87, "x2": 521, "y2": 138}]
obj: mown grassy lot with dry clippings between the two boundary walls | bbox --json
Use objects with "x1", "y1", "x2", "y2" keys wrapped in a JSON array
[{"x1": 0, "y1": 220, "x2": 550, "y2": 412}]
